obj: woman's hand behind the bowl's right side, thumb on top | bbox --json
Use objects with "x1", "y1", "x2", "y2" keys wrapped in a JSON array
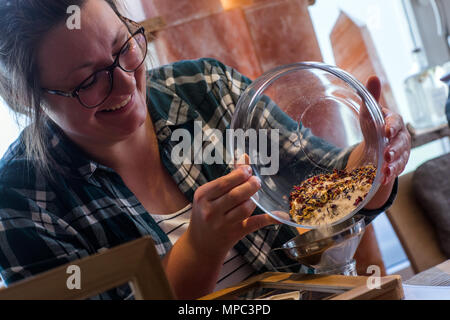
[{"x1": 361, "y1": 77, "x2": 411, "y2": 209}]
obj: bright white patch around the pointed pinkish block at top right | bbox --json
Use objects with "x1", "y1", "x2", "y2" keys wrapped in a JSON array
[{"x1": 310, "y1": 0, "x2": 416, "y2": 121}]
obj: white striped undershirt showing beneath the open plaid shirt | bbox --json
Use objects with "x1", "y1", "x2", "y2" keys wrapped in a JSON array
[{"x1": 151, "y1": 204, "x2": 254, "y2": 291}]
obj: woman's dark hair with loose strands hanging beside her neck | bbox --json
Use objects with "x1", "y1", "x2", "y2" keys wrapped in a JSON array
[{"x1": 0, "y1": 0, "x2": 125, "y2": 175}]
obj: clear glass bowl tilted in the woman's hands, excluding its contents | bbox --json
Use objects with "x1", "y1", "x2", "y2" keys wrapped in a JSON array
[{"x1": 227, "y1": 62, "x2": 387, "y2": 229}]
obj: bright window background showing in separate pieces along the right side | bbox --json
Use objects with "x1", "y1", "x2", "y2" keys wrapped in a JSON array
[{"x1": 309, "y1": 0, "x2": 450, "y2": 273}]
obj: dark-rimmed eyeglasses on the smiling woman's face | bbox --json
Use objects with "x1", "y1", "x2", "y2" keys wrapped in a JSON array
[{"x1": 42, "y1": 19, "x2": 147, "y2": 109}]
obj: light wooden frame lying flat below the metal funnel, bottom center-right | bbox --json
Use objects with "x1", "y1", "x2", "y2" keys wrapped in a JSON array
[{"x1": 201, "y1": 272, "x2": 404, "y2": 300}]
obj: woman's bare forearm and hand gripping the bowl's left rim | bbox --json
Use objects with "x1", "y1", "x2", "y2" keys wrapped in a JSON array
[{"x1": 163, "y1": 165, "x2": 277, "y2": 299}]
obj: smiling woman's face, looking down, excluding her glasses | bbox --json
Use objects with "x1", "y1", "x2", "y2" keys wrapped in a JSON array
[{"x1": 38, "y1": 0, "x2": 147, "y2": 146}]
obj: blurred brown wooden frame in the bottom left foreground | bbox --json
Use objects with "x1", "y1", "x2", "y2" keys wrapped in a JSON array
[{"x1": 0, "y1": 236, "x2": 174, "y2": 300}]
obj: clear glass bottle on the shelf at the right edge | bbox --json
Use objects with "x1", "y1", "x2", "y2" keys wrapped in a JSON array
[{"x1": 404, "y1": 48, "x2": 450, "y2": 129}]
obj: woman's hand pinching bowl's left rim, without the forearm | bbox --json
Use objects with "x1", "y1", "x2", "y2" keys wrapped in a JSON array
[{"x1": 187, "y1": 165, "x2": 276, "y2": 259}]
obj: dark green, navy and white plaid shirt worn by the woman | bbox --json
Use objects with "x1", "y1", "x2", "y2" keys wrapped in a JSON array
[{"x1": 0, "y1": 59, "x2": 395, "y2": 299}]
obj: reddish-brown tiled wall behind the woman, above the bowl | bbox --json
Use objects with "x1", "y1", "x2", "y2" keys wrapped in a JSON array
[{"x1": 142, "y1": 0, "x2": 322, "y2": 78}]
